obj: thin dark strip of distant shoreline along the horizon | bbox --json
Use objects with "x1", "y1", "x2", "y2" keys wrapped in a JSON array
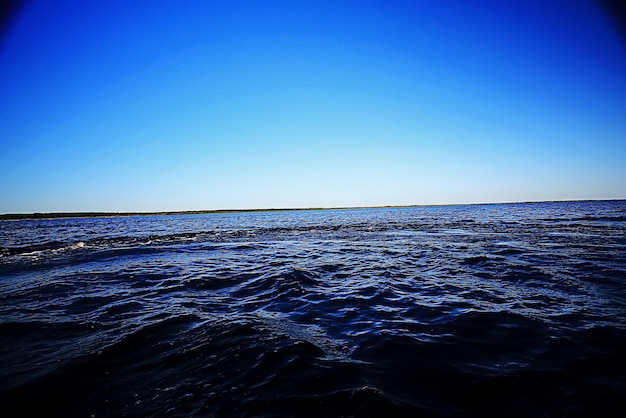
[{"x1": 0, "y1": 199, "x2": 626, "y2": 221}]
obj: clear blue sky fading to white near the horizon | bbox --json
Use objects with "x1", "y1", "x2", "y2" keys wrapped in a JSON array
[{"x1": 0, "y1": 0, "x2": 626, "y2": 213}]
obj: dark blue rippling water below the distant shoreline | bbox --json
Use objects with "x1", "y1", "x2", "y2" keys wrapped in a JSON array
[{"x1": 0, "y1": 201, "x2": 626, "y2": 417}]
